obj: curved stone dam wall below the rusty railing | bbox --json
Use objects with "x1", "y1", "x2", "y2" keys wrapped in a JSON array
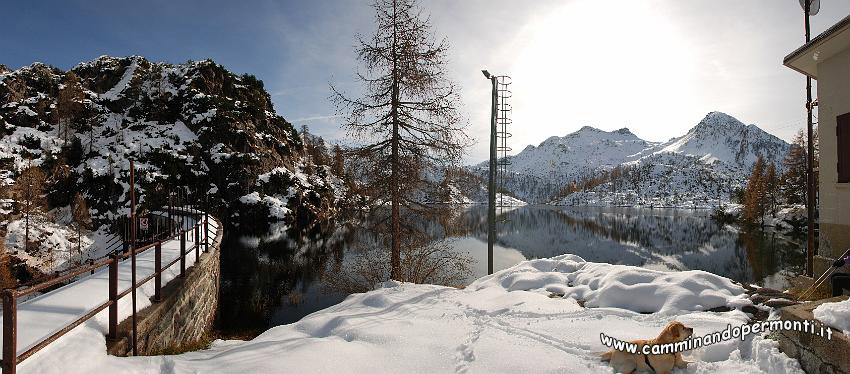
[{"x1": 107, "y1": 219, "x2": 222, "y2": 356}]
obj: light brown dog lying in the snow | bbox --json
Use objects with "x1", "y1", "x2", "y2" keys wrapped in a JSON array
[{"x1": 602, "y1": 321, "x2": 694, "y2": 374}]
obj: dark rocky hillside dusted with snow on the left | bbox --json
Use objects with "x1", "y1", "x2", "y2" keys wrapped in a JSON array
[{"x1": 0, "y1": 56, "x2": 343, "y2": 254}]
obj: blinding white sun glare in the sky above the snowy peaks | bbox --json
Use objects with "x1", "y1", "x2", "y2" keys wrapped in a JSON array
[{"x1": 511, "y1": 1, "x2": 697, "y2": 144}]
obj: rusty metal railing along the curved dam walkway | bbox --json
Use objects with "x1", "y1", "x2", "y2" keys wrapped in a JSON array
[{"x1": 0, "y1": 211, "x2": 214, "y2": 374}]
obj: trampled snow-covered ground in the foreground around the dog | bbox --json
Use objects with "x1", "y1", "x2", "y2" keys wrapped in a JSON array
[{"x1": 19, "y1": 255, "x2": 802, "y2": 374}]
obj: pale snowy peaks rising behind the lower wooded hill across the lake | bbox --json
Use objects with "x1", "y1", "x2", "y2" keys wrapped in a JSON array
[{"x1": 467, "y1": 111, "x2": 790, "y2": 205}]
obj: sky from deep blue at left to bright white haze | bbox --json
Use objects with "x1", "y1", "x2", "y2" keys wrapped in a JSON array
[{"x1": 0, "y1": 0, "x2": 850, "y2": 162}]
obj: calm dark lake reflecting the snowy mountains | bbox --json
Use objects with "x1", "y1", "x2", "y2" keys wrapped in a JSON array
[{"x1": 212, "y1": 205, "x2": 804, "y2": 337}]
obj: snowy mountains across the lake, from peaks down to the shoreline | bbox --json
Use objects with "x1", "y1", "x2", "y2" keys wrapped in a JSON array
[{"x1": 469, "y1": 112, "x2": 790, "y2": 206}]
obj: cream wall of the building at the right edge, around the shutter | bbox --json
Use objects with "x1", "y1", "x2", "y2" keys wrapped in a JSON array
[{"x1": 818, "y1": 49, "x2": 850, "y2": 258}]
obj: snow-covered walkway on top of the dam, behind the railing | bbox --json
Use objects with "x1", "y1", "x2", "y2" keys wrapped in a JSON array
[{"x1": 0, "y1": 212, "x2": 218, "y2": 366}]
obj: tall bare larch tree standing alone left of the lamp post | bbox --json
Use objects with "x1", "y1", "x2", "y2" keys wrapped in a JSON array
[{"x1": 332, "y1": 0, "x2": 469, "y2": 279}]
